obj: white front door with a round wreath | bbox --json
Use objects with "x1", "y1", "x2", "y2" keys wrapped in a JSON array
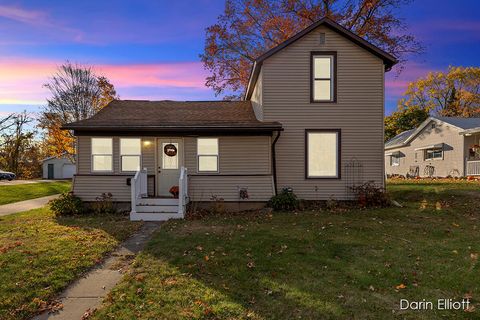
[{"x1": 157, "y1": 138, "x2": 183, "y2": 197}]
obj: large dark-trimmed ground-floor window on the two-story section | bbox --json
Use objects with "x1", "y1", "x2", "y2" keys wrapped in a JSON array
[{"x1": 306, "y1": 130, "x2": 340, "y2": 178}]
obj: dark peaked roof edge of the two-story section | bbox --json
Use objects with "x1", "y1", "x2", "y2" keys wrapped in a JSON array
[{"x1": 245, "y1": 17, "x2": 398, "y2": 100}]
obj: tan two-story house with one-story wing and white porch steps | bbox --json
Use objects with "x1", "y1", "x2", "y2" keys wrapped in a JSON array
[{"x1": 65, "y1": 18, "x2": 397, "y2": 220}]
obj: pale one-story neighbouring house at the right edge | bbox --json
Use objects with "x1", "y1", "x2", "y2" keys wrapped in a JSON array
[{"x1": 385, "y1": 117, "x2": 480, "y2": 177}]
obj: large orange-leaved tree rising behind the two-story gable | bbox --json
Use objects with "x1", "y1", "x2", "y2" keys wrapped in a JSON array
[{"x1": 201, "y1": 0, "x2": 423, "y2": 98}]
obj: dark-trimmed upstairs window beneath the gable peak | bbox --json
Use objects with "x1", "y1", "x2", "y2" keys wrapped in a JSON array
[{"x1": 311, "y1": 52, "x2": 336, "y2": 102}]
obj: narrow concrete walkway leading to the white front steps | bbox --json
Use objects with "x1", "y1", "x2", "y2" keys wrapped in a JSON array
[{"x1": 33, "y1": 222, "x2": 160, "y2": 320}]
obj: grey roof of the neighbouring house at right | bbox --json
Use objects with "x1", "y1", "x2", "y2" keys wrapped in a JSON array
[{"x1": 385, "y1": 117, "x2": 480, "y2": 149}]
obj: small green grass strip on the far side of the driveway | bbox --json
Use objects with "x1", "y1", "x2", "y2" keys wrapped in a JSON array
[{"x1": 0, "y1": 181, "x2": 72, "y2": 205}]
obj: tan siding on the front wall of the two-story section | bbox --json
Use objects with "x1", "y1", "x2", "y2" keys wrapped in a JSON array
[{"x1": 262, "y1": 27, "x2": 384, "y2": 200}]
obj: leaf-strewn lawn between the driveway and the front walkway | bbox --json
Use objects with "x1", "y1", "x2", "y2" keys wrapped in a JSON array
[{"x1": 0, "y1": 208, "x2": 140, "y2": 319}]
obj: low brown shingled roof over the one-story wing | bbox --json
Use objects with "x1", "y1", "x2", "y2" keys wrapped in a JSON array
[{"x1": 63, "y1": 100, "x2": 282, "y2": 132}]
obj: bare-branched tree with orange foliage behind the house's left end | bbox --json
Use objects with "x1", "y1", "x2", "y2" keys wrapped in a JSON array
[{"x1": 40, "y1": 62, "x2": 118, "y2": 160}]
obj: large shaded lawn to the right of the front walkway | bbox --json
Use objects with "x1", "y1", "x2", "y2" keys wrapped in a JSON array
[{"x1": 93, "y1": 182, "x2": 480, "y2": 319}]
